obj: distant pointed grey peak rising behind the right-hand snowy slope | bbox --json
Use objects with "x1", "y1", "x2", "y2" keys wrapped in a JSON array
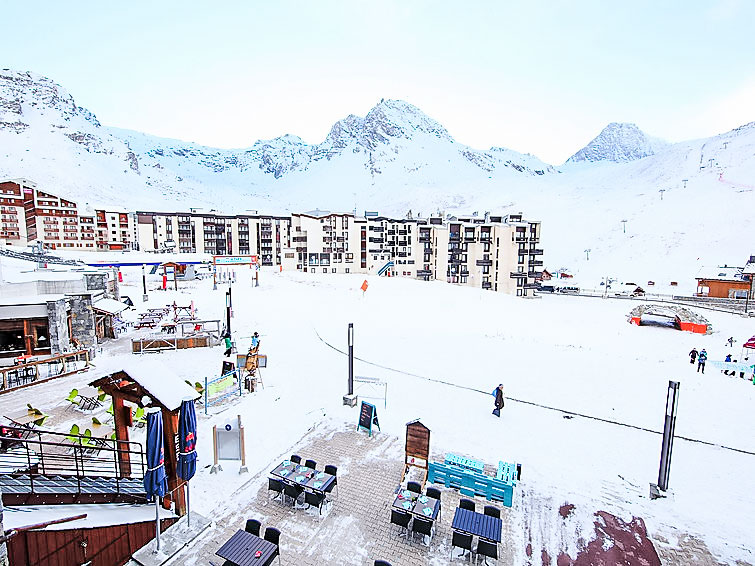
[{"x1": 566, "y1": 122, "x2": 669, "y2": 163}]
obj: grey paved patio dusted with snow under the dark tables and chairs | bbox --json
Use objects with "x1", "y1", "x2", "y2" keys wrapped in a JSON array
[{"x1": 179, "y1": 425, "x2": 513, "y2": 566}]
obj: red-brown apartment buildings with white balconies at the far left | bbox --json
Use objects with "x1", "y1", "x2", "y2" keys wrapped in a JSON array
[{"x1": 0, "y1": 179, "x2": 136, "y2": 250}]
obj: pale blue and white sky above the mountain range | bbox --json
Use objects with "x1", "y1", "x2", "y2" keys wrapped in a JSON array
[{"x1": 0, "y1": 0, "x2": 755, "y2": 164}]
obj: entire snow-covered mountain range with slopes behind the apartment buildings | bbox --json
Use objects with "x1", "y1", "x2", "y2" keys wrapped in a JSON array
[{"x1": 0, "y1": 70, "x2": 755, "y2": 283}]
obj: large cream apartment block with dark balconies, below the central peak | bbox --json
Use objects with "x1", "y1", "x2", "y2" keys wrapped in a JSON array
[{"x1": 283, "y1": 210, "x2": 543, "y2": 296}]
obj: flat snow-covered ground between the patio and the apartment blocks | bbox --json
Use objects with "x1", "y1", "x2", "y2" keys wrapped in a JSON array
[{"x1": 0, "y1": 258, "x2": 755, "y2": 563}]
